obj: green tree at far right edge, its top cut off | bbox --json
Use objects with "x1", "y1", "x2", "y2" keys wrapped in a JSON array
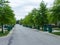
[{"x1": 52, "y1": 0, "x2": 60, "y2": 25}]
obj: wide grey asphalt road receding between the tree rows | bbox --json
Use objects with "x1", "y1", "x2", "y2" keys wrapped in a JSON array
[{"x1": 0, "y1": 24, "x2": 60, "y2": 45}]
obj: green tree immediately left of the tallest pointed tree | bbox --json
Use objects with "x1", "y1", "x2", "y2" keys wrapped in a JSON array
[{"x1": 33, "y1": 9, "x2": 41, "y2": 29}]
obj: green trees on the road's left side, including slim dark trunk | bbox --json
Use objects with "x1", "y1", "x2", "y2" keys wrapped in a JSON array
[{"x1": 0, "y1": 0, "x2": 16, "y2": 33}]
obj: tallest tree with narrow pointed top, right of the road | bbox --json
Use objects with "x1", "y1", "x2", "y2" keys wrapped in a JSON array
[{"x1": 39, "y1": 1, "x2": 48, "y2": 28}]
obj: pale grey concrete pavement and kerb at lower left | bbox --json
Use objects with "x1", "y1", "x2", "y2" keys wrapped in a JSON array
[{"x1": 0, "y1": 28, "x2": 14, "y2": 45}]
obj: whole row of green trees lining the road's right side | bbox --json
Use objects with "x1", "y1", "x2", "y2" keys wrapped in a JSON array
[{"x1": 20, "y1": 0, "x2": 60, "y2": 29}]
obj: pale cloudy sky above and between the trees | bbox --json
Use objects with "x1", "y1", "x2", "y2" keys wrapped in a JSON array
[{"x1": 9, "y1": 0, "x2": 54, "y2": 20}]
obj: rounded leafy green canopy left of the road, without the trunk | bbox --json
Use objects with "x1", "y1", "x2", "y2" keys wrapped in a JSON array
[{"x1": 0, "y1": 4, "x2": 15, "y2": 24}]
